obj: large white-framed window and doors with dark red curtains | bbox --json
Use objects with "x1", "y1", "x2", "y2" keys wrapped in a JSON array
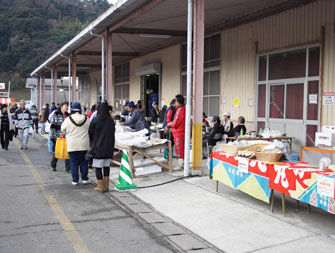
[{"x1": 255, "y1": 46, "x2": 320, "y2": 149}]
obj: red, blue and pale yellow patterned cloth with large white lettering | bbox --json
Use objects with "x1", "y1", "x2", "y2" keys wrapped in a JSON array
[{"x1": 209, "y1": 152, "x2": 335, "y2": 214}]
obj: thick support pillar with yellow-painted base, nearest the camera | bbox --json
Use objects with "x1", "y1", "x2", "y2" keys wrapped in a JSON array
[{"x1": 192, "y1": 0, "x2": 205, "y2": 170}]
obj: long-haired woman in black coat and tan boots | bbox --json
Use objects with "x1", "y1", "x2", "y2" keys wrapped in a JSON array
[{"x1": 89, "y1": 101, "x2": 115, "y2": 192}]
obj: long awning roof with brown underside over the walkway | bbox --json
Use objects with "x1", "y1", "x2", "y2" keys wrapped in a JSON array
[{"x1": 32, "y1": 0, "x2": 315, "y2": 75}]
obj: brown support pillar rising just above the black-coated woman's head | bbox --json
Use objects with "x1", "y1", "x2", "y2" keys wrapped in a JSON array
[{"x1": 106, "y1": 31, "x2": 114, "y2": 105}]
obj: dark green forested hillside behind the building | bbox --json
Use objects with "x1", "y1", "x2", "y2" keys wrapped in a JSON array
[{"x1": 0, "y1": 0, "x2": 110, "y2": 88}]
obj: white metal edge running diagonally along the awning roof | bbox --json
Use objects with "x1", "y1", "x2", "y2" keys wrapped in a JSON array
[{"x1": 30, "y1": 0, "x2": 135, "y2": 76}]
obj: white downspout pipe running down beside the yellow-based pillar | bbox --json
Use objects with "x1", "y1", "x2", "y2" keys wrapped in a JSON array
[{"x1": 184, "y1": 0, "x2": 193, "y2": 177}]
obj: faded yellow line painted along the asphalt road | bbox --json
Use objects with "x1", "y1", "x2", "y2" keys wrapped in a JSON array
[{"x1": 14, "y1": 140, "x2": 91, "y2": 253}]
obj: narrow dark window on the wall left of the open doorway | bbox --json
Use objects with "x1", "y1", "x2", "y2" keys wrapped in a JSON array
[{"x1": 114, "y1": 62, "x2": 129, "y2": 111}]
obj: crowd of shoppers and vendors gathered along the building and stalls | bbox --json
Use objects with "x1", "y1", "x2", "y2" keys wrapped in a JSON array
[{"x1": 0, "y1": 94, "x2": 247, "y2": 186}]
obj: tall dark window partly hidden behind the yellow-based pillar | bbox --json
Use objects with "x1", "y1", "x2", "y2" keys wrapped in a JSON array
[{"x1": 181, "y1": 34, "x2": 221, "y2": 116}]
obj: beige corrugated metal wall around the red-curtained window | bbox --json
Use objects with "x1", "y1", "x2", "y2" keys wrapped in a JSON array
[{"x1": 221, "y1": 0, "x2": 335, "y2": 125}]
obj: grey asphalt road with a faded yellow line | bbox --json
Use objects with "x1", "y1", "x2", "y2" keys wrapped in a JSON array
[{"x1": 0, "y1": 136, "x2": 175, "y2": 253}]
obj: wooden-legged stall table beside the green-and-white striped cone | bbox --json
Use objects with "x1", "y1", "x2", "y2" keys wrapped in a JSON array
[{"x1": 112, "y1": 140, "x2": 172, "y2": 178}]
